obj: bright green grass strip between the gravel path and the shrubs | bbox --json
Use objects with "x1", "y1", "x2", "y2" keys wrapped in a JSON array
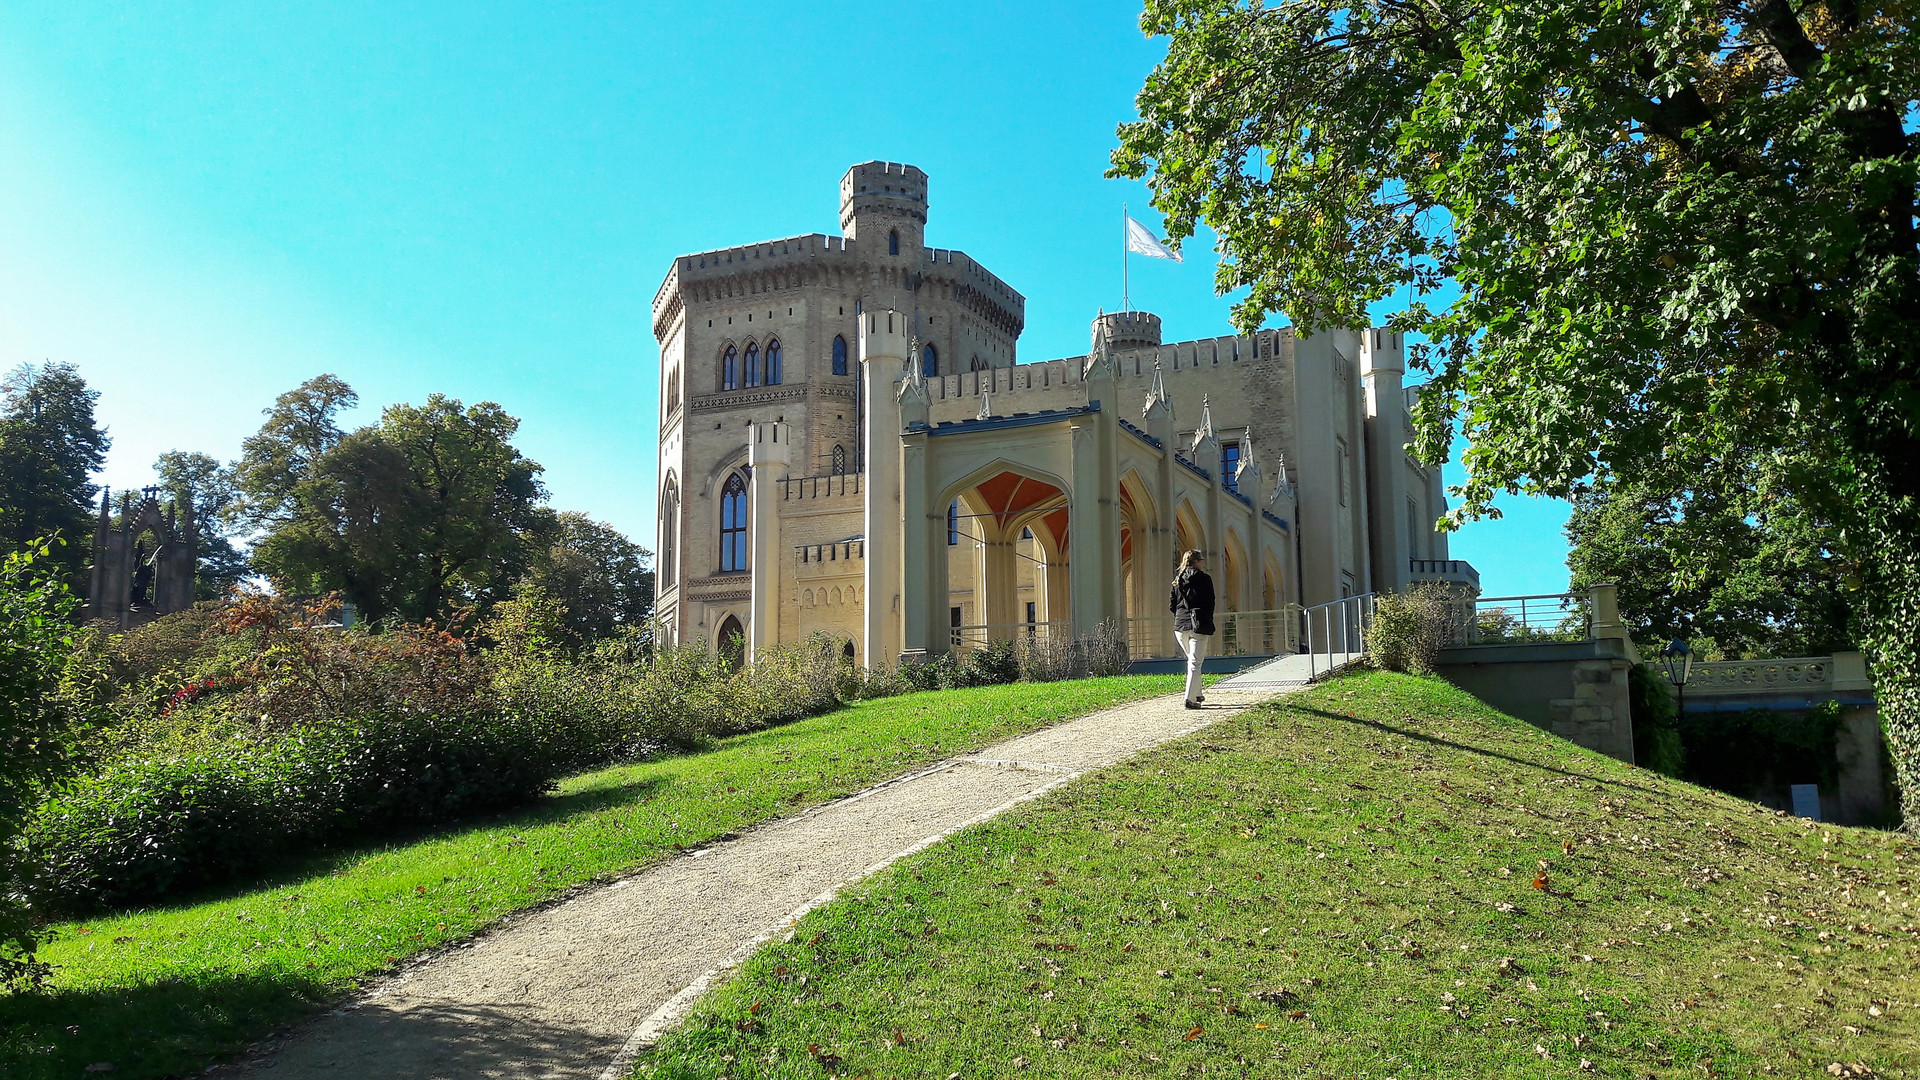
[{"x1": 0, "y1": 675, "x2": 1179, "y2": 1080}]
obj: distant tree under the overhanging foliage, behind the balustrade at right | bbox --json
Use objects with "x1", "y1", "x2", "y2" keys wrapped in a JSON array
[{"x1": 1567, "y1": 482, "x2": 1859, "y2": 659}]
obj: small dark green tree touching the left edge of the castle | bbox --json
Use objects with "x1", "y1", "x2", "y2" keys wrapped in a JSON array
[{"x1": 526, "y1": 511, "x2": 653, "y2": 644}]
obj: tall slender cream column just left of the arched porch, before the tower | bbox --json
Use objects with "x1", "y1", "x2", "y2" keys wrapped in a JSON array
[{"x1": 860, "y1": 309, "x2": 908, "y2": 669}]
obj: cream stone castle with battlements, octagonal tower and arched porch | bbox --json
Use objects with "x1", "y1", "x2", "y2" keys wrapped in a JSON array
[{"x1": 653, "y1": 161, "x2": 1478, "y2": 667}]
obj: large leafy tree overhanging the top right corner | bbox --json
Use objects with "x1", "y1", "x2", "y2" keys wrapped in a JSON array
[{"x1": 1114, "y1": 0, "x2": 1920, "y2": 830}]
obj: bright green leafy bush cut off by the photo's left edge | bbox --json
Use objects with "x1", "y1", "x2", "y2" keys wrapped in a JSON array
[{"x1": 0, "y1": 544, "x2": 91, "y2": 990}]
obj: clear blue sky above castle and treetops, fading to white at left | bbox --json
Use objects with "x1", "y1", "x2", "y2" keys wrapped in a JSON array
[{"x1": 0, "y1": 0, "x2": 1567, "y2": 594}]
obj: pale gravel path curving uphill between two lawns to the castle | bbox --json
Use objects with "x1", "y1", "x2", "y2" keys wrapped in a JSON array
[{"x1": 234, "y1": 682, "x2": 1284, "y2": 1080}]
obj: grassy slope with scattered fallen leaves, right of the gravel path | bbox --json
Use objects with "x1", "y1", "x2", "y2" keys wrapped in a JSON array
[{"x1": 639, "y1": 675, "x2": 1920, "y2": 1080}]
